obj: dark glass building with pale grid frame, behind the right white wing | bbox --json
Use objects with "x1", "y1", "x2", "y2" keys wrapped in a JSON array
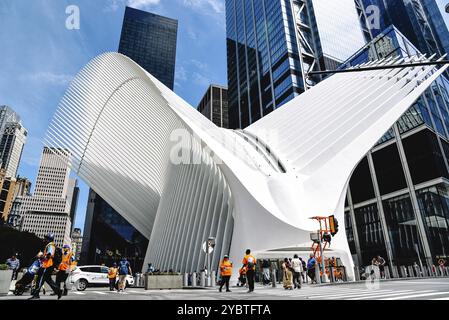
[{"x1": 344, "y1": 26, "x2": 449, "y2": 273}]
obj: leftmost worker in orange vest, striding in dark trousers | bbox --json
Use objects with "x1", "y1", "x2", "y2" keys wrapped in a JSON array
[{"x1": 30, "y1": 233, "x2": 62, "y2": 300}]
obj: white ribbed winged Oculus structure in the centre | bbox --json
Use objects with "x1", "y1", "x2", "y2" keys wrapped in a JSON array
[{"x1": 46, "y1": 53, "x2": 447, "y2": 278}]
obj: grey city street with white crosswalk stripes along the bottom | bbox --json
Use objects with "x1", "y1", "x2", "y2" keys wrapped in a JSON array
[{"x1": 0, "y1": 278, "x2": 449, "y2": 301}]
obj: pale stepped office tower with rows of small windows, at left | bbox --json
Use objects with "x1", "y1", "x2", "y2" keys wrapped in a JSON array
[{"x1": 20, "y1": 147, "x2": 77, "y2": 245}]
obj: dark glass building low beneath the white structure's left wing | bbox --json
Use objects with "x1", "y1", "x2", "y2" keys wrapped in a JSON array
[{"x1": 80, "y1": 190, "x2": 148, "y2": 272}]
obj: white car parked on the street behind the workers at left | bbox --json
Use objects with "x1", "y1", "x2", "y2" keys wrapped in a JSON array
[{"x1": 69, "y1": 266, "x2": 134, "y2": 291}]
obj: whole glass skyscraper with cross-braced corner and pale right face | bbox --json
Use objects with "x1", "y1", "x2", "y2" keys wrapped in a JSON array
[{"x1": 226, "y1": 0, "x2": 365, "y2": 129}]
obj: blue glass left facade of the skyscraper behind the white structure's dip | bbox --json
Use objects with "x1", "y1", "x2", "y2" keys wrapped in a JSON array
[{"x1": 226, "y1": 0, "x2": 304, "y2": 129}]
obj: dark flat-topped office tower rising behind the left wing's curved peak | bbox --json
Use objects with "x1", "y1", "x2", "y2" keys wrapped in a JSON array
[{"x1": 118, "y1": 7, "x2": 178, "y2": 90}]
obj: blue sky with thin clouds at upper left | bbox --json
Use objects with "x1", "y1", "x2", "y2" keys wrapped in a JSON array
[{"x1": 0, "y1": 0, "x2": 227, "y2": 229}]
